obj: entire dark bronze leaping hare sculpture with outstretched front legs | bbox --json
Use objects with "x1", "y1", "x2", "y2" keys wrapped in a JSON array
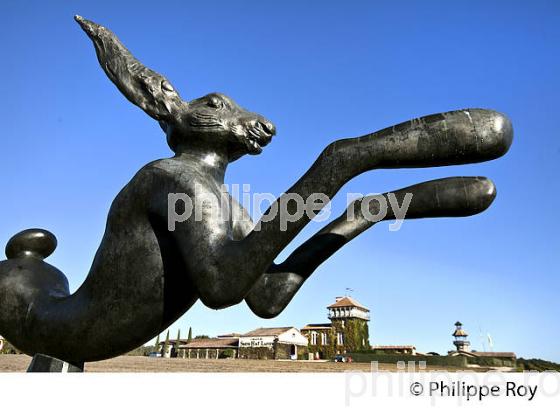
[{"x1": 0, "y1": 16, "x2": 513, "y2": 370}]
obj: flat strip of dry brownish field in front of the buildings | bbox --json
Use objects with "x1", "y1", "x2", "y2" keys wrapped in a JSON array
[{"x1": 0, "y1": 355, "x2": 468, "y2": 373}]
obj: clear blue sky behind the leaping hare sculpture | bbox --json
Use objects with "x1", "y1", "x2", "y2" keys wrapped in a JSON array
[{"x1": 0, "y1": 0, "x2": 560, "y2": 361}]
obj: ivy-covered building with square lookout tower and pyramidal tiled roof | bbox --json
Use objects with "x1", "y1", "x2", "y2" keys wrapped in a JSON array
[{"x1": 301, "y1": 296, "x2": 370, "y2": 359}]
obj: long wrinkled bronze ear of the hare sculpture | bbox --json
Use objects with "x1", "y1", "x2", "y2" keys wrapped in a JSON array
[{"x1": 74, "y1": 16, "x2": 187, "y2": 123}]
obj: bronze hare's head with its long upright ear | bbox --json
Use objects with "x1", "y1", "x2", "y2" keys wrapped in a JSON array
[{"x1": 75, "y1": 16, "x2": 276, "y2": 161}]
